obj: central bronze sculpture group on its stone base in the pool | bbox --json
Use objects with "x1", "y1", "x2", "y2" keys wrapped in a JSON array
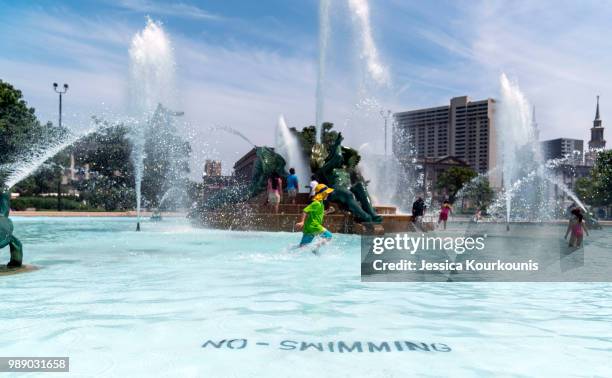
[{"x1": 189, "y1": 120, "x2": 424, "y2": 234}]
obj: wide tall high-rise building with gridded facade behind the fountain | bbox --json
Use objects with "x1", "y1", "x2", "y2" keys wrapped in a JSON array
[{"x1": 393, "y1": 96, "x2": 499, "y2": 186}]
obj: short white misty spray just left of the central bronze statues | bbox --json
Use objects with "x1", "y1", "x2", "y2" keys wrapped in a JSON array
[{"x1": 275, "y1": 114, "x2": 310, "y2": 192}]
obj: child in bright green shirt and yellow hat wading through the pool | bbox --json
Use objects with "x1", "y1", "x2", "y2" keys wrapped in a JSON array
[{"x1": 295, "y1": 184, "x2": 334, "y2": 247}]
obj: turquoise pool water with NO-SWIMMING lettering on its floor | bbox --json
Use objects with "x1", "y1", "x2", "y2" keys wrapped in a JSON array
[{"x1": 0, "y1": 218, "x2": 612, "y2": 377}]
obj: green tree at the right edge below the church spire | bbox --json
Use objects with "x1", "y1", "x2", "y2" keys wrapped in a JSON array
[{"x1": 576, "y1": 150, "x2": 612, "y2": 206}]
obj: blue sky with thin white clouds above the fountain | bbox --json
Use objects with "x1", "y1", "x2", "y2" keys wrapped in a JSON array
[{"x1": 0, "y1": 0, "x2": 612, "y2": 171}]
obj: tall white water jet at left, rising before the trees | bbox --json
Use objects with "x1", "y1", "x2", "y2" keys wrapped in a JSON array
[{"x1": 128, "y1": 18, "x2": 175, "y2": 231}]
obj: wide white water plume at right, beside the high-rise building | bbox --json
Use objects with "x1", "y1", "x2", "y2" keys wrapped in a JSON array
[{"x1": 448, "y1": 74, "x2": 588, "y2": 230}]
